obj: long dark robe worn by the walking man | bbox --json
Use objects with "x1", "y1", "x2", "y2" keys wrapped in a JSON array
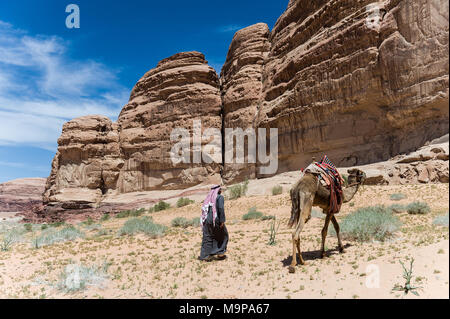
[{"x1": 199, "y1": 194, "x2": 228, "y2": 260}]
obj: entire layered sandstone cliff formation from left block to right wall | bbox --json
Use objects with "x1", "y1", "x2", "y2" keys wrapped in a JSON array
[{"x1": 40, "y1": 0, "x2": 449, "y2": 212}]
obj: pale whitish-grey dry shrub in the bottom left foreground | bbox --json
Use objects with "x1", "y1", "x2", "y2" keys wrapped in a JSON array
[{"x1": 57, "y1": 264, "x2": 108, "y2": 292}]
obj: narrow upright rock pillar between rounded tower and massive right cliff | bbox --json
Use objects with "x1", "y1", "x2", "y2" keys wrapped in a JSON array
[{"x1": 221, "y1": 23, "x2": 270, "y2": 182}]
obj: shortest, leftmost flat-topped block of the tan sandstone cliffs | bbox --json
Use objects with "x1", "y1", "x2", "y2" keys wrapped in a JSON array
[{"x1": 44, "y1": 116, "x2": 124, "y2": 204}]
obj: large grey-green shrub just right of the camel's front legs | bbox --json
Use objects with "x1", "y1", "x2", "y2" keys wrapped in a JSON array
[{"x1": 330, "y1": 206, "x2": 401, "y2": 242}]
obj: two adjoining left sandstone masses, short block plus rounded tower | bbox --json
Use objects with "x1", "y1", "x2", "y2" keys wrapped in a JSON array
[{"x1": 44, "y1": 52, "x2": 222, "y2": 211}]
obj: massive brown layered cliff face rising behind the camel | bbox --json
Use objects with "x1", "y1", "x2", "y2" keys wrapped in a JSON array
[{"x1": 257, "y1": 0, "x2": 449, "y2": 176}]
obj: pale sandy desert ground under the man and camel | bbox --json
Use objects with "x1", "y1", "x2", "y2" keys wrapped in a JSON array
[{"x1": 0, "y1": 184, "x2": 449, "y2": 298}]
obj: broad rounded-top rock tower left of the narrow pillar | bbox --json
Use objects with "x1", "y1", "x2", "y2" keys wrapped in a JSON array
[{"x1": 117, "y1": 52, "x2": 222, "y2": 193}]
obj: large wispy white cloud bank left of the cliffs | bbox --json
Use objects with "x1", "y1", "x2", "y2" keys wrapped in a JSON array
[{"x1": 0, "y1": 21, "x2": 129, "y2": 150}]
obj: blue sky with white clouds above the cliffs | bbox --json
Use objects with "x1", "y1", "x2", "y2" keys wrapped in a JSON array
[{"x1": 0, "y1": 0, "x2": 288, "y2": 183}]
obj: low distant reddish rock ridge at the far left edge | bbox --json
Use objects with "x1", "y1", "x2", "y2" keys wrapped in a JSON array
[{"x1": 0, "y1": 178, "x2": 45, "y2": 212}]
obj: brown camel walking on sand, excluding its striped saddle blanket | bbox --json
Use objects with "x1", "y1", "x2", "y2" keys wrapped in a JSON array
[{"x1": 289, "y1": 169, "x2": 366, "y2": 273}]
